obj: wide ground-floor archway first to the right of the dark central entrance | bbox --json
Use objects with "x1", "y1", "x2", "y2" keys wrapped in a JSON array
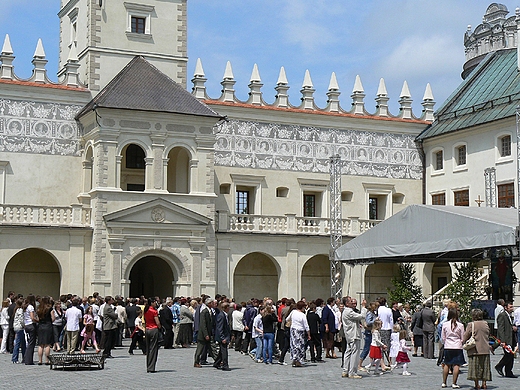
[{"x1": 233, "y1": 252, "x2": 278, "y2": 302}]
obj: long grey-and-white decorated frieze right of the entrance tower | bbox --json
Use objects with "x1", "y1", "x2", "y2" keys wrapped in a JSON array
[{"x1": 215, "y1": 120, "x2": 422, "y2": 180}]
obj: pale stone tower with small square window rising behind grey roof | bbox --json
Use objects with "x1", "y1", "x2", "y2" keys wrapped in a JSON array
[{"x1": 58, "y1": 0, "x2": 188, "y2": 94}]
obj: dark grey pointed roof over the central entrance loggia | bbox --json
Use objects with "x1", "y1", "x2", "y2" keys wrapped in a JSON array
[{"x1": 76, "y1": 56, "x2": 222, "y2": 118}]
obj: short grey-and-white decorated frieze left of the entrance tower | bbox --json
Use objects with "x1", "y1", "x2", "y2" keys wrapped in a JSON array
[{"x1": 0, "y1": 99, "x2": 81, "y2": 156}]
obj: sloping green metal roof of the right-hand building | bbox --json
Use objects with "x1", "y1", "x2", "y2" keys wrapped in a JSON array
[{"x1": 417, "y1": 48, "x2": 520, "y2": 140}]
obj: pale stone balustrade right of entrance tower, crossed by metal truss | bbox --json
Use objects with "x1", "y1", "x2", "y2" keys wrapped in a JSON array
[{"x1": 217, "y1": 211, "x2": 380, "y2": 237}]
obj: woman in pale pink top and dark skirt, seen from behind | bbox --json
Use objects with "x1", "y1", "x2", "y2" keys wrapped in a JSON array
[{"x1": 441, "y1": 308, "x2": 466, "y2": 389}]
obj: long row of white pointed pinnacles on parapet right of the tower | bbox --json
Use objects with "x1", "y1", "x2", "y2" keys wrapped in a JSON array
[{"x1": 191, "y1": 58, "x2": 435, "y2": 122}]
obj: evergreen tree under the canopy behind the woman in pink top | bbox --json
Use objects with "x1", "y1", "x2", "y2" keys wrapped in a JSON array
[{"x1": 444, "y1": 261, "x2": 481, "y2": 324}]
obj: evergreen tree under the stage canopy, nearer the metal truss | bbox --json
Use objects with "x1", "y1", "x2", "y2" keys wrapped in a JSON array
[{"x1": 387, "y1": 263, "x2": 424, "y2": 307}]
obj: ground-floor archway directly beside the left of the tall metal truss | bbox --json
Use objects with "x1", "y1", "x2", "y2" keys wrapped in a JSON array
[{"x1": 301, "y1": 255, "x2": 330, "y2": 302}]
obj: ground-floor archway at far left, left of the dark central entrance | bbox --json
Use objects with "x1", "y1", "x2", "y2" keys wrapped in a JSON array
[{"x1": 3, "y1": 248, "x2": 60, "y2": 299}]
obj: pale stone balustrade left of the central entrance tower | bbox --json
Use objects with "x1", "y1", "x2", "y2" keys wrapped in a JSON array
[{"x1": 0, "y1": 204, "x2": 90, "y2": 226}]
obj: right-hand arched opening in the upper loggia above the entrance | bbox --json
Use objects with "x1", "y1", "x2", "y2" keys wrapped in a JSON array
[{"x1": 166, "y1": 146, "x2": 192, "y2": 194}]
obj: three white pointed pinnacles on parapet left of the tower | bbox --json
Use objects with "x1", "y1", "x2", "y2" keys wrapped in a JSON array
[{"x1": 0, "y1": 34, "x2": 85, "y2": 88}]
